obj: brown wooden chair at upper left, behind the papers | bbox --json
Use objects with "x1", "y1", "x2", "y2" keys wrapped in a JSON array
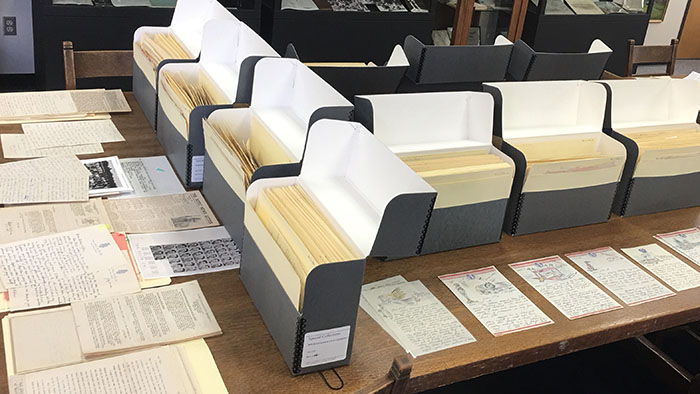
[{"x1": 63, "y1": 41, "x2": 133, "y2": 90}]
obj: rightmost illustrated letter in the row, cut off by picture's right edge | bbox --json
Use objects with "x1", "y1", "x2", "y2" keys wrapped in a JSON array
[{"x1": 622, "y1": 244, "x2": 700, "y2": 291}]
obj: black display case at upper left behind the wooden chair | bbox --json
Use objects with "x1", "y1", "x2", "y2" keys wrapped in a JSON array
[{"x1": 32, "y1": 0, "x2": 261, "y2": 90}]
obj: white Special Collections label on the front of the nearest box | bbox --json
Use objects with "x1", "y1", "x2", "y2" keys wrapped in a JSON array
[{"x1": 301, "y1": 326, "x2": 350, "y2": 368}]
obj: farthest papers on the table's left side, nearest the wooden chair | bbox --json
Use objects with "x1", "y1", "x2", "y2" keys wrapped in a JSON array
[{"x1": 0, "y1": 89, "x2": 131, "y2": 124}]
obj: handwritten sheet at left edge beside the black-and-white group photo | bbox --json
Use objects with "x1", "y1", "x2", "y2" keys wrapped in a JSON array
[{"x1": 0, "y1": 157, "x2": 90, "y2": 204}]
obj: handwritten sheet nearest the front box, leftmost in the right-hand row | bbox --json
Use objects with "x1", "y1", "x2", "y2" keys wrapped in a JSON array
[{"x1": 365, "y1": 281, "x2": 476, "y2": 357}]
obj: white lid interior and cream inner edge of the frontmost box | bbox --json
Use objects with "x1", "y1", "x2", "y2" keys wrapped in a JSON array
[{"x1": 245, "y1": 119, "x2": 434, "y2": 309}]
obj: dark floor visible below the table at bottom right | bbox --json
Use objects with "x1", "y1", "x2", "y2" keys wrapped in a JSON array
[{"x1": 425, "y1": 323, "x2": 700, "y2": 394}]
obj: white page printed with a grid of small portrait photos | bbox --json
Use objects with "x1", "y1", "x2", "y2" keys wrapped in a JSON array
[{"x1": 129, "y1": 226, "x2": 241, "y2": 279}]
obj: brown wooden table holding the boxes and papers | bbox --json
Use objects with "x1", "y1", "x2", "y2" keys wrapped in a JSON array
[{"x1": 0, "y1": 95, "x2": 700, "y2": 393}]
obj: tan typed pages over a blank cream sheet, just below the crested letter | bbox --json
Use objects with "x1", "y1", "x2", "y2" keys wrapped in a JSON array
[{"x1": 3, "y1": 281, "x2": 221, "y2": 373}]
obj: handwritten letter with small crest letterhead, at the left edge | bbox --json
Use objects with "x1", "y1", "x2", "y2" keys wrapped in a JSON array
[{"x1": 0, "y1": 226, "x2": 140, "y2": 311}]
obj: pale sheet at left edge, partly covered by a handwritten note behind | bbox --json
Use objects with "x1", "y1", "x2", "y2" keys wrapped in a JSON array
[{"x1": 0, "y1": 134, "x2": 104, "y2": 159}]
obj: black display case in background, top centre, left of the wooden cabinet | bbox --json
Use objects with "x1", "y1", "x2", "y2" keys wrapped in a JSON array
[{"x1": 261, "y1": 0, "x2": 436, "y2": 64}]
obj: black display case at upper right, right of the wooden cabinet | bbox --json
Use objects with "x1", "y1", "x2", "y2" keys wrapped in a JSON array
[{"x1": 522, "y1": 0, "x2": 653, "y2": 75}]
